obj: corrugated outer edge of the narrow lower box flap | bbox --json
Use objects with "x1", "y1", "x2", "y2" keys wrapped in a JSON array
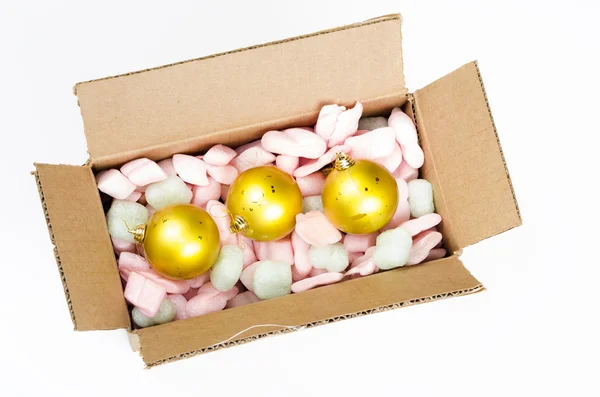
[{"x1": 139, "y1": 284, "x2": 485, "y2": 368}]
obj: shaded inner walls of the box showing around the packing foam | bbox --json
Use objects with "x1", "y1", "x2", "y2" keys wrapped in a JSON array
[{"x1": 95, "y1": 94, "x2": 462, "y2": 332}]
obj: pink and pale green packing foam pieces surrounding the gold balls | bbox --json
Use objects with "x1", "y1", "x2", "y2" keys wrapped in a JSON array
[{"x1": 97, "y1": 102, "x2": 446, "y2": 328}]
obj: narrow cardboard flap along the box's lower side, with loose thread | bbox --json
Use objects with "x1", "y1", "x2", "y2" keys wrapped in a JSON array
[{"x1": 135, "y1": 256, "x2": 482, "y2": 365}]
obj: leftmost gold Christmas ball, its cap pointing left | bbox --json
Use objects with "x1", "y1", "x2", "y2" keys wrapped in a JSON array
[{"x1": 134, "y1": 204, "x2": 220, "y2": 280}]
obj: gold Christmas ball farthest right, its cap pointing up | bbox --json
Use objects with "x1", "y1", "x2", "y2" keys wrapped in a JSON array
[{"x1": 322, "y1": 153, "x2": 398, "y2": 234}]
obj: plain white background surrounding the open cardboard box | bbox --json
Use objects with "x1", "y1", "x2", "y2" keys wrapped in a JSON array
[{"x1": 0, "y1": 0, "x2": 600, "y2": 396}]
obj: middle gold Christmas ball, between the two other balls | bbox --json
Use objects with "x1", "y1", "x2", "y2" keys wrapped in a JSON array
[{"x1": 225, "y1": 166, "x2": 302, "y2": 241}]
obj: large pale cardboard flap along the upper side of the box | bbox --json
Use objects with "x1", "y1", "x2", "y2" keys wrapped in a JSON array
[{"x1": 75, "y1": 15, "x2": 407, "y2": 168}]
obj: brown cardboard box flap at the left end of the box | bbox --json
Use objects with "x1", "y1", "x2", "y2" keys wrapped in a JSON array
[{"x1": 34, "y1": 164, "x2": 130, "y2": 331}]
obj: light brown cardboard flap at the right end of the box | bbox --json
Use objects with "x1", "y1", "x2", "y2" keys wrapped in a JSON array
[{"x1": 414, "y1": 62, "x2": 521, "y2": 251}]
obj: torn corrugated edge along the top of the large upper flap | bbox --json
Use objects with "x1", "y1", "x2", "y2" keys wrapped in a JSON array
[{"x1": 73, "y1": 14, "x2": 404, "y2": 95}]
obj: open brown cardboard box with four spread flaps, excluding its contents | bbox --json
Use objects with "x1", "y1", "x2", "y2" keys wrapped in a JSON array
[{"x1": 34, "y1": 15, "x2": 521, "y2": 366}]
